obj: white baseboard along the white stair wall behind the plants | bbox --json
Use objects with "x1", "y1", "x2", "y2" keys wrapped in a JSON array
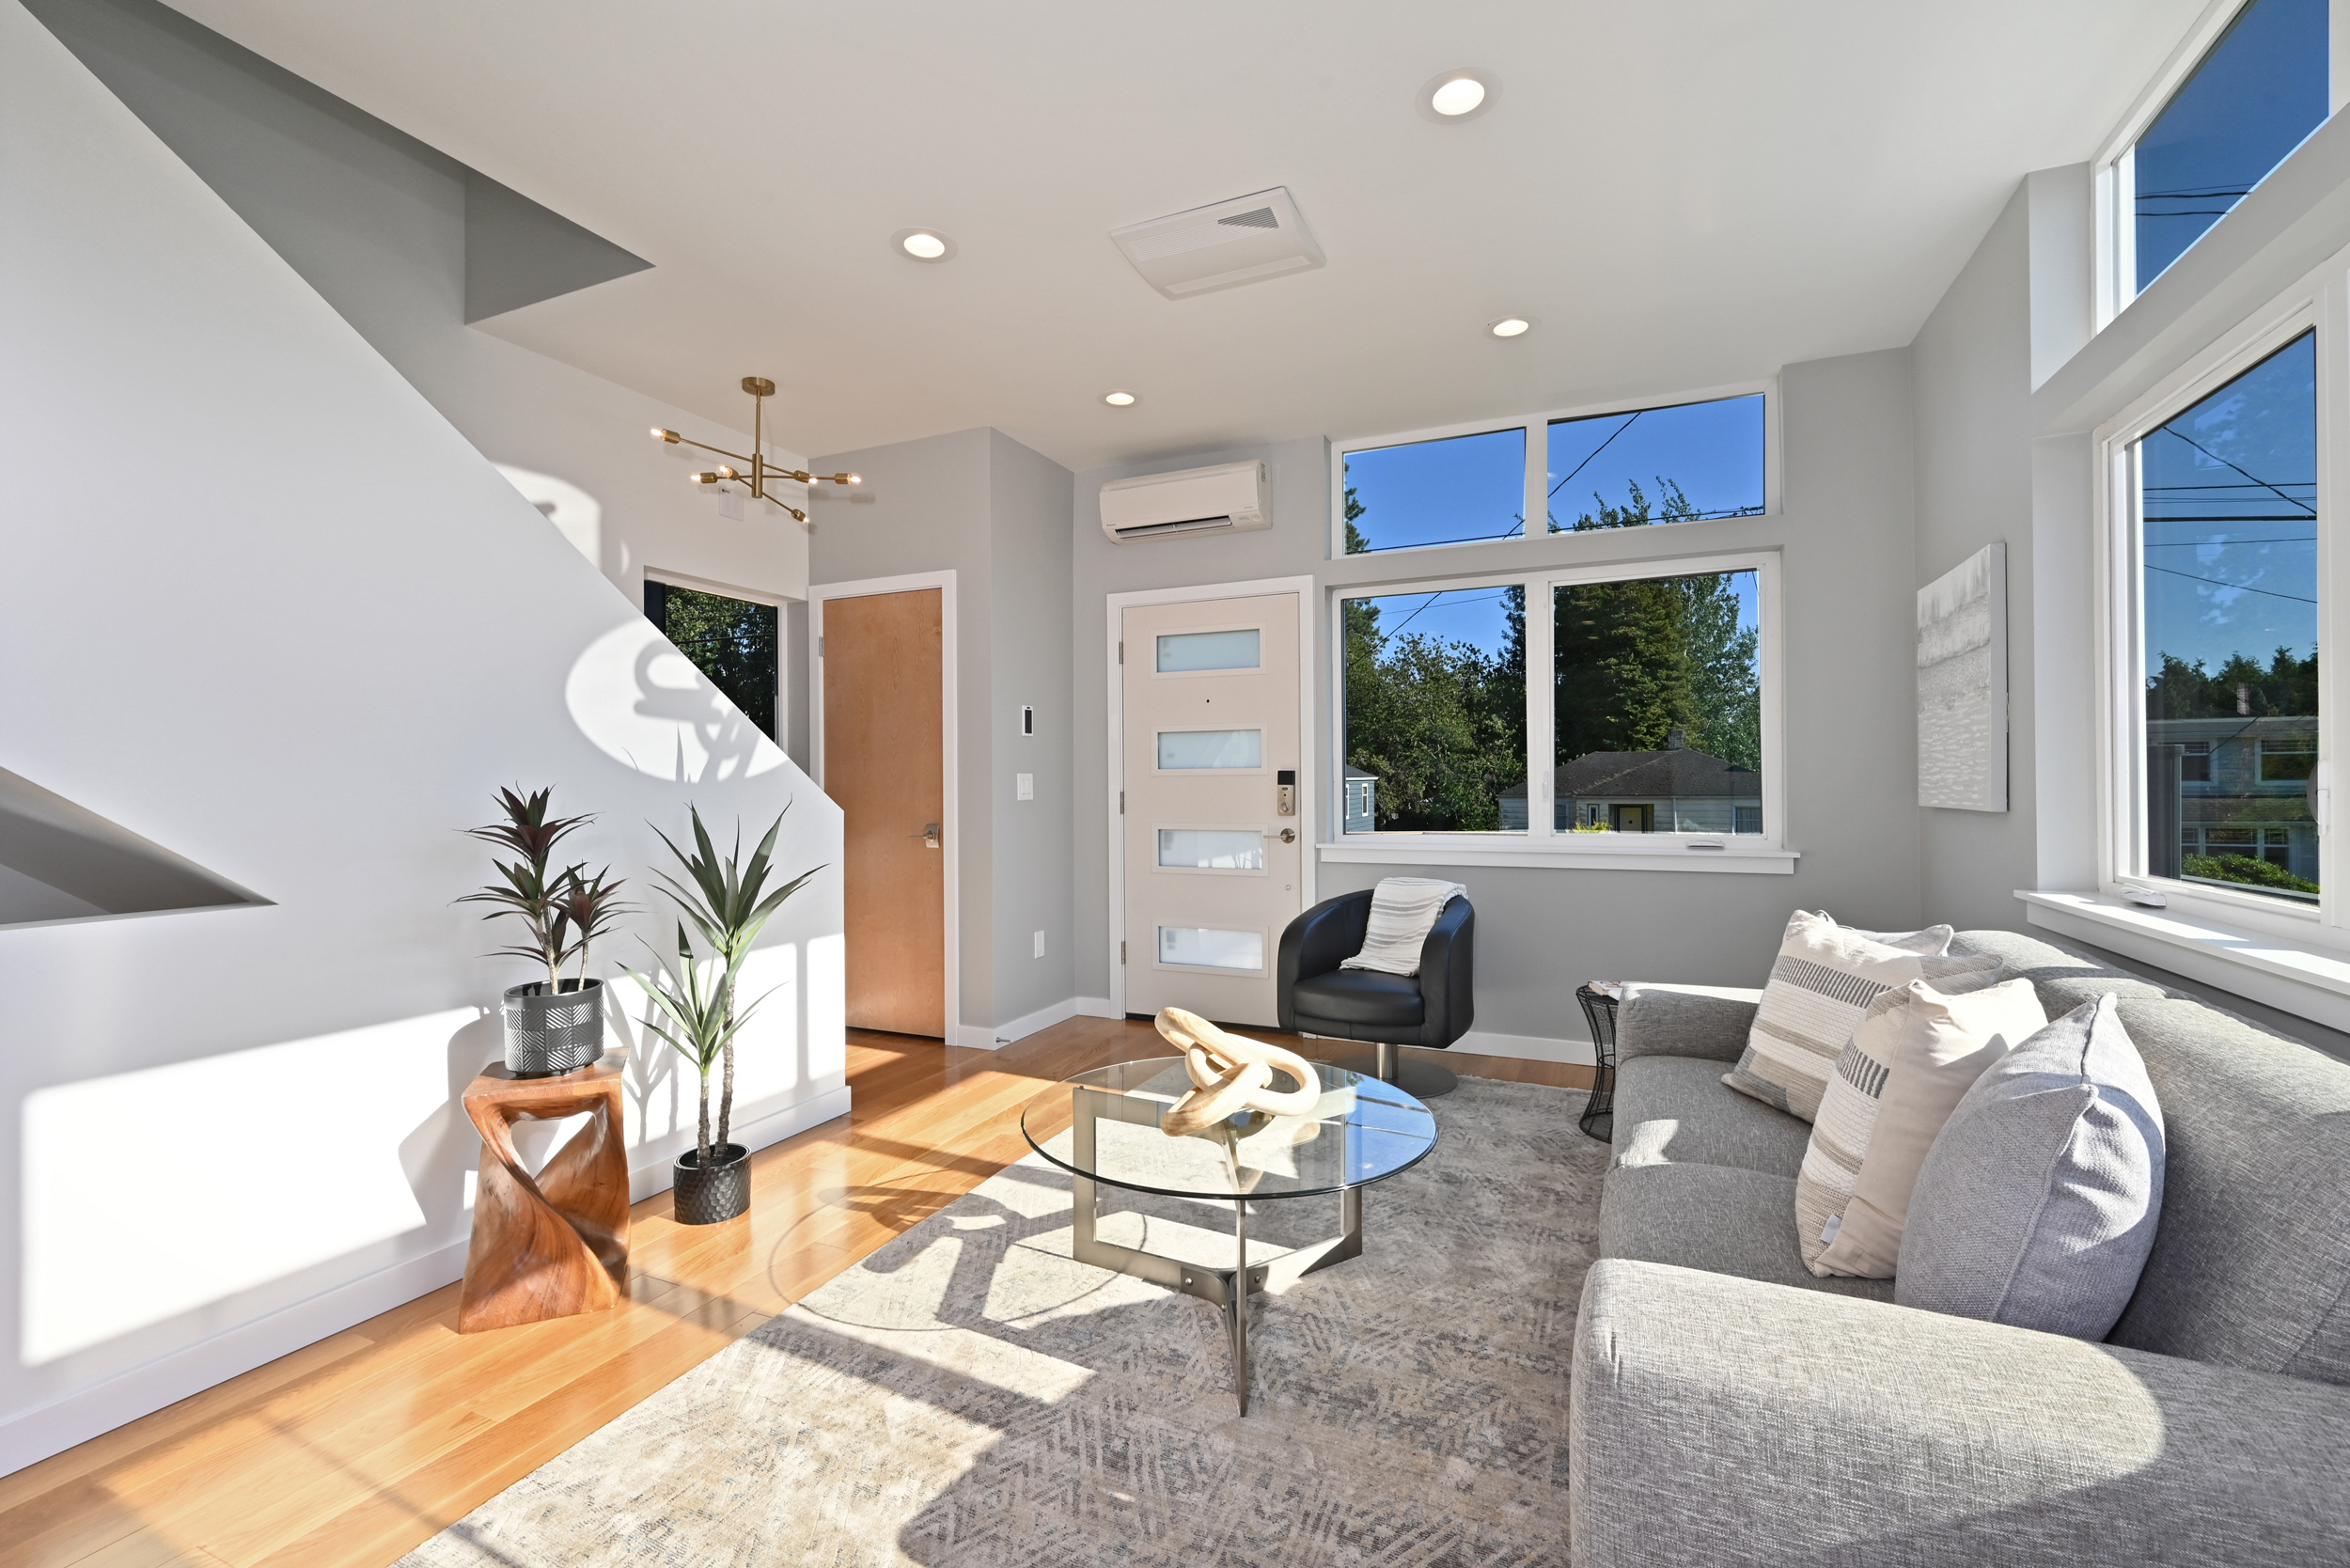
[{"x1": 0, "y1": 1084, "x2": 849, "y2": 1476}]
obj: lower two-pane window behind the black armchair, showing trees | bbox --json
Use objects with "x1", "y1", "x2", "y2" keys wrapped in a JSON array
[{"x1": 1340, "y1": 564, "x2": 1777, "y2": 849}]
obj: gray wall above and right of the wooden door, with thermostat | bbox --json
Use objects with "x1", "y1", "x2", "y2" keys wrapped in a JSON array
[{"x1": 811, "y1": 431, "x2": 1074, "y2": 1034}]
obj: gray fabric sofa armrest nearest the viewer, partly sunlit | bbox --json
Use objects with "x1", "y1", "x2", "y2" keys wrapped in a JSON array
[{"x1": 1568, "y1": 1260, "x2": 2350, "y2": 1568}]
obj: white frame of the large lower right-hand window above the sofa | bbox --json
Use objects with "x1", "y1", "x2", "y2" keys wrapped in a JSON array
[{"x1": 2092, "y1": 249, "x2": 2350, "y2": 952}]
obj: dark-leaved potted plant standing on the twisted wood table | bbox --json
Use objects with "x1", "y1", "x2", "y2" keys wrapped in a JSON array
[{"x1": 459, "y1": 790, "x2": 628, "y2": 1079}]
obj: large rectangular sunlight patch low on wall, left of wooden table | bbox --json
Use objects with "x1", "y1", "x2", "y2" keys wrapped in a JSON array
[{"x1": 22, "y1": 1009, "x2": 479, "y2": 1366}]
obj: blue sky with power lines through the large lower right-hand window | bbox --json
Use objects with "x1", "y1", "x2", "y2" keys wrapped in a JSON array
[{"x1": 2138, "y1": 334, "x2": 2317, "y2": 675}]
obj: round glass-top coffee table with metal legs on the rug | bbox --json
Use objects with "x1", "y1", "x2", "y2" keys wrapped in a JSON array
[{"x1": 1020, "y1": 1056, "x2": 1436, "y2": 1415}]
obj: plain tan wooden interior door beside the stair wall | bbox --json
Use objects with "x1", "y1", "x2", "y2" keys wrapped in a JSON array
[{"x1": 821, "y1": 588, "x2": 948, "y2": 1039}]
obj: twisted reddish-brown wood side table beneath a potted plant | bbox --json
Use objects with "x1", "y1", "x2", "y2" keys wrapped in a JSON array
[{"x1": 456, "y1": 1051, "x2": 628, "y2": 1333}]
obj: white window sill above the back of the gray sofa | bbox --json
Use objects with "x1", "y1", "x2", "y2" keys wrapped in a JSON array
[{"x1": 2016, "y1": 891, "x2": 2350, "y2": 1029}]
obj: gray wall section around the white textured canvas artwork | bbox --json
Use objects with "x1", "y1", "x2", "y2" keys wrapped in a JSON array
[{"x1": 1911, "y1": 183, "x2": 2038, "y2": 931}]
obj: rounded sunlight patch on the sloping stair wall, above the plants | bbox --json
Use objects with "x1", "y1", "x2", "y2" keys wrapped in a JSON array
[{"x1": 564, "y1": 616, "x2": 785, "y2": 783}]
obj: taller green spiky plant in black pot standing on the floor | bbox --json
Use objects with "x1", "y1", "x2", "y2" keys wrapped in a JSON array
[{"x1": 630, "y1": 807, "x2": 825, "y2": 1225}]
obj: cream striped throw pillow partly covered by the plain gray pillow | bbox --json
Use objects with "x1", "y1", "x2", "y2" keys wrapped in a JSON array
[{"x1": 1795, "y1": 980, "x2": 2047, "y2": 1278}]
